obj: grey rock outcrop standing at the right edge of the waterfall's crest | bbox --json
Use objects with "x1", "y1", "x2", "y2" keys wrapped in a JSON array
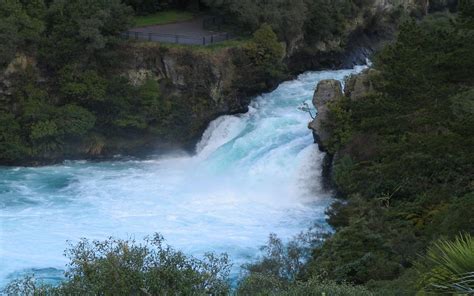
[{"x1": 309, "y1": 80, "x2": 344, "y2": 151}]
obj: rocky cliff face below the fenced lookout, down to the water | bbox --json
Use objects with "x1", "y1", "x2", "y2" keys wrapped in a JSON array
[{"x1": 123, "y1": 43, "x2": 280, "y2": 150}]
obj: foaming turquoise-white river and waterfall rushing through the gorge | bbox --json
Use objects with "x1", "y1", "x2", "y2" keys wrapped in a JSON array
[{"x1": 0, "y1": 67, "x2": 363, "y2": 287}]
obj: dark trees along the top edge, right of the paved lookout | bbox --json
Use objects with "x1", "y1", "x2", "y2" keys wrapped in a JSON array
[{"x1": 204, "y1": 0, "x2": 406, "y2": 50}]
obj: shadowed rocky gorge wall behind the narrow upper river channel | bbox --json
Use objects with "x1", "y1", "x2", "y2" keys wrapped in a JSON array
[{"x1": 287, "y1": 0, "x2": 432, "y2": 73}]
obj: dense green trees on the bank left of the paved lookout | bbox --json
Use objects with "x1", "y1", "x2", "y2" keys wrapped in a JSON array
[{"x1": 0, "y1": 0, "x2": 183, "y2": 164}]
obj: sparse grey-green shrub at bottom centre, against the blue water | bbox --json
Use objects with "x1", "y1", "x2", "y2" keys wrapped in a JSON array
[{"x1": 236, "y1": 228, "x2": 372, "y2": 296}]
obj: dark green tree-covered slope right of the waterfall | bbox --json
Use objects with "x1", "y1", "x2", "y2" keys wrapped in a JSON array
[{"x1": 309, "y1": 6, "x2": 474, "y2": 295}]
